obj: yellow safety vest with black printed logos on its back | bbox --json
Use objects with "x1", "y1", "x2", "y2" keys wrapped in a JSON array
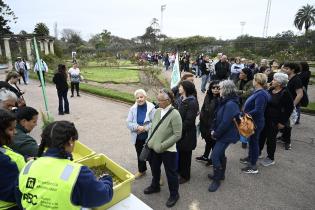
[{"x1": 19, "y1": 157, "x2": 81, "y2": 210}]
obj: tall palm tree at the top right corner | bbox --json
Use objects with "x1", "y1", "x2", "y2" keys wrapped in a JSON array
[{"x1": 294, "y1": 4, "x2": 315, "y2": 34}]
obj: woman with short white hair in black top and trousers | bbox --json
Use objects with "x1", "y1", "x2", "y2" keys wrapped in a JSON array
[{"x1": 259, "y1": 73, "x2": 294, "y2": 166}]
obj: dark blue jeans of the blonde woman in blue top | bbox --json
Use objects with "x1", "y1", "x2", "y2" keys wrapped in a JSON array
[{"x1": 248, "y1": 126, "x2": 263, "y2": 166}]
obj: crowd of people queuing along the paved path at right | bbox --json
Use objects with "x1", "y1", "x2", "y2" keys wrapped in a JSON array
[{"x1": 127, "y1": 53, "x2": 310, "y2": 207}]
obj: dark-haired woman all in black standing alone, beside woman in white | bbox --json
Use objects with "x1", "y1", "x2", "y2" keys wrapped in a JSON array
[{"x1": 53, "y1": 64, "x2": 70, "y2": 115}]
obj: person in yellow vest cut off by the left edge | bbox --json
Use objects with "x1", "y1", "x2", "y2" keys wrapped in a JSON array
[{"x1": 0, "y1": 109, "x2": 25, "y2": 210}]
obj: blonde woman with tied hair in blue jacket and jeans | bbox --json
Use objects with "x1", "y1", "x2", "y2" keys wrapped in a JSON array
[{"x1": 240, "y1": 73, "x2": 270, "y2": 174}]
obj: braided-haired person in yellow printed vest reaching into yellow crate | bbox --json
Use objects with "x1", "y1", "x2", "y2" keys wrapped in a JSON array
[{"x1": 17, "y1": 121, "x2": 113, "y2": 210}]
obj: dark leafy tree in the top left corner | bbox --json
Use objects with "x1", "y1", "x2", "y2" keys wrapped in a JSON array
[{"x1": 0, "y1": 0, "x2": 17, "y2": 35}]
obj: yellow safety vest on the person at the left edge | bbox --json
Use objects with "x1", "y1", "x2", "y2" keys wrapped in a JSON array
[{"x1": 0, "y1": 146, "x2": 25, "y2": 210}]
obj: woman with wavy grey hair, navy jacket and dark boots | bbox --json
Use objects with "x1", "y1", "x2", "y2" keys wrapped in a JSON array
[{"x1": 208, "y1": 80, "x2": 240, "y2": 192}]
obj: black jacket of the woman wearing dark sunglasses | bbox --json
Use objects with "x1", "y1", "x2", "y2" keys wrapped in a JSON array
[{"x1": 200, "y1": 93, "x2": 219, "y2": 140}]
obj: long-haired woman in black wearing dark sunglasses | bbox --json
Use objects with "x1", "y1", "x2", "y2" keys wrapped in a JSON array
[{"x1": 196, "y1": 80, "x2": 220, "y2": 166}]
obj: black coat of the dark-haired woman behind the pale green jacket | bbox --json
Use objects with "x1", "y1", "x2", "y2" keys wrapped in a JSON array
[{"x1": 177, "y1": 96, "x2": 199, "y2": 151}]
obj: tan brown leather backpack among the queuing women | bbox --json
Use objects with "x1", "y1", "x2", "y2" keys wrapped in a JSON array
[{"x1": 234, "y1": 113, "x2": 256, "y2": 138}]
